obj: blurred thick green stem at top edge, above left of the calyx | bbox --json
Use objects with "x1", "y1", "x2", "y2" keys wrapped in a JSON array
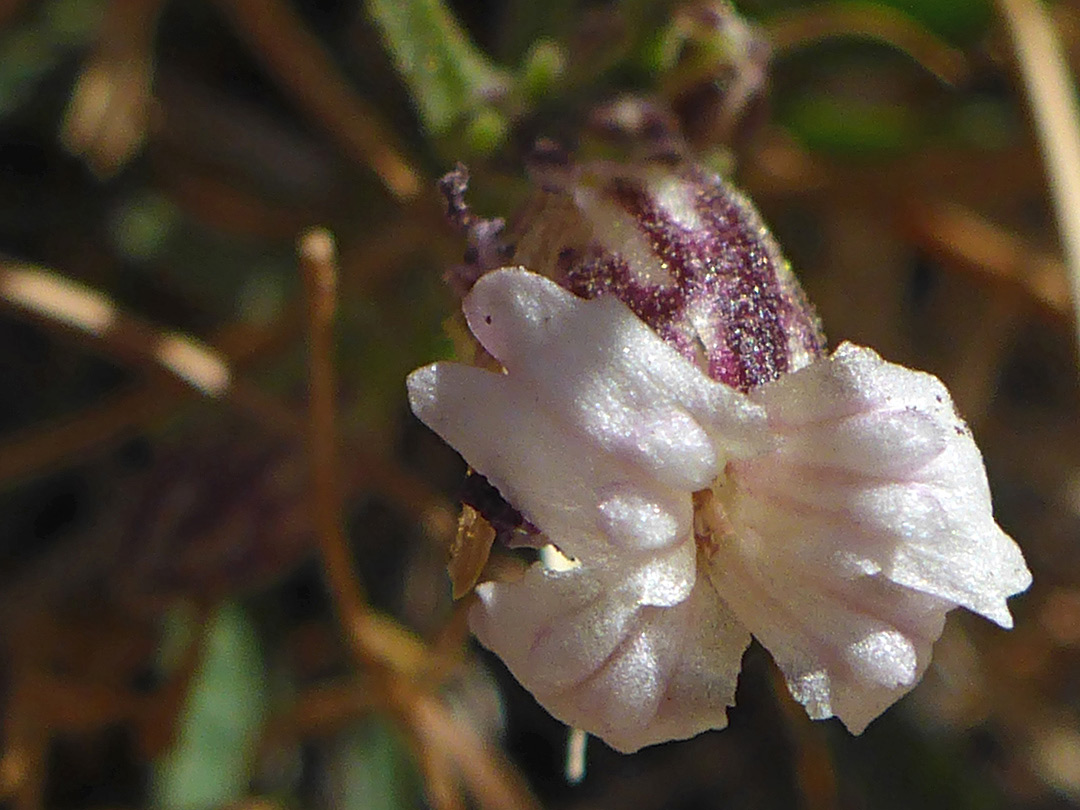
[{"x1": 366, "y1": 0, "x2": 508, "y2": 135}]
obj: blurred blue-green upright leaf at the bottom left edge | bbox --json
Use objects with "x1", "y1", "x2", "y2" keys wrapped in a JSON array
[{"x1": 151, "y1": 604, "x2": 267, "y2": 810}]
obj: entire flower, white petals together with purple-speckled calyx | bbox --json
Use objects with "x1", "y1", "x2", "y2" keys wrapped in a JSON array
[{"x1": 408, "y1": 163, "x2": 1030, "y2": 751}]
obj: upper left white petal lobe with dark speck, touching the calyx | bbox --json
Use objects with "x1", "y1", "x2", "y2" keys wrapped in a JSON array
[{"x1": 462, "y1": 273, "x2": 764, "y2": 491}]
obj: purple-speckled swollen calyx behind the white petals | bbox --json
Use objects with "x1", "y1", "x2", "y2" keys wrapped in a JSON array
[{"x1": 509, "y1": 163, "x2": 825, "y2": 391}]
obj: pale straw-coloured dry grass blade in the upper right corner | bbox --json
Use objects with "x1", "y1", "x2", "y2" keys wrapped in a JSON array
[{"x1": 998, "y1": 0, "x2": 1080, "y2": 358}]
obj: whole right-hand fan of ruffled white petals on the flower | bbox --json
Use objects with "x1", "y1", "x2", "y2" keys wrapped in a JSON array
[{"x1": 710, "y1": 345, "x2": 1030, "y2": 731}]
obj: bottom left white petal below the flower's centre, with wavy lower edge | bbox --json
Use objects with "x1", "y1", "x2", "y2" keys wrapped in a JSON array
[{"x1": 470, "y1": 557, "x2": 750, "y2": 752}]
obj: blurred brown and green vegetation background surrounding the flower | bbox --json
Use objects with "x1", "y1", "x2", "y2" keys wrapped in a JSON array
[{"x1": 0, "y1": 0, "x2": 1080, "y2": 810}]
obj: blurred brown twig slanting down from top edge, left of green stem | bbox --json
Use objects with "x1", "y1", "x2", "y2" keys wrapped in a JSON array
[{"x1": 218, "y1": 0, "x2": 420, "y2": 200}]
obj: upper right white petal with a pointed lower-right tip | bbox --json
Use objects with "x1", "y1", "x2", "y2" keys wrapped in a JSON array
[{"x1": 747, "y1": 343, "x2": 1031, "y2": 627}]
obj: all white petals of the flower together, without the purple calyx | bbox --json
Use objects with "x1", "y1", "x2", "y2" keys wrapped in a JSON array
[{"x1": 408, "y1": 269, "x2": 1030, "y2": 752}]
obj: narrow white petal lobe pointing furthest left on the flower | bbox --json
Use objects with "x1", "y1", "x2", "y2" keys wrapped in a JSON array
[{"x1": 408, "y1": 363, "x2": 693, "y2": 582}]
